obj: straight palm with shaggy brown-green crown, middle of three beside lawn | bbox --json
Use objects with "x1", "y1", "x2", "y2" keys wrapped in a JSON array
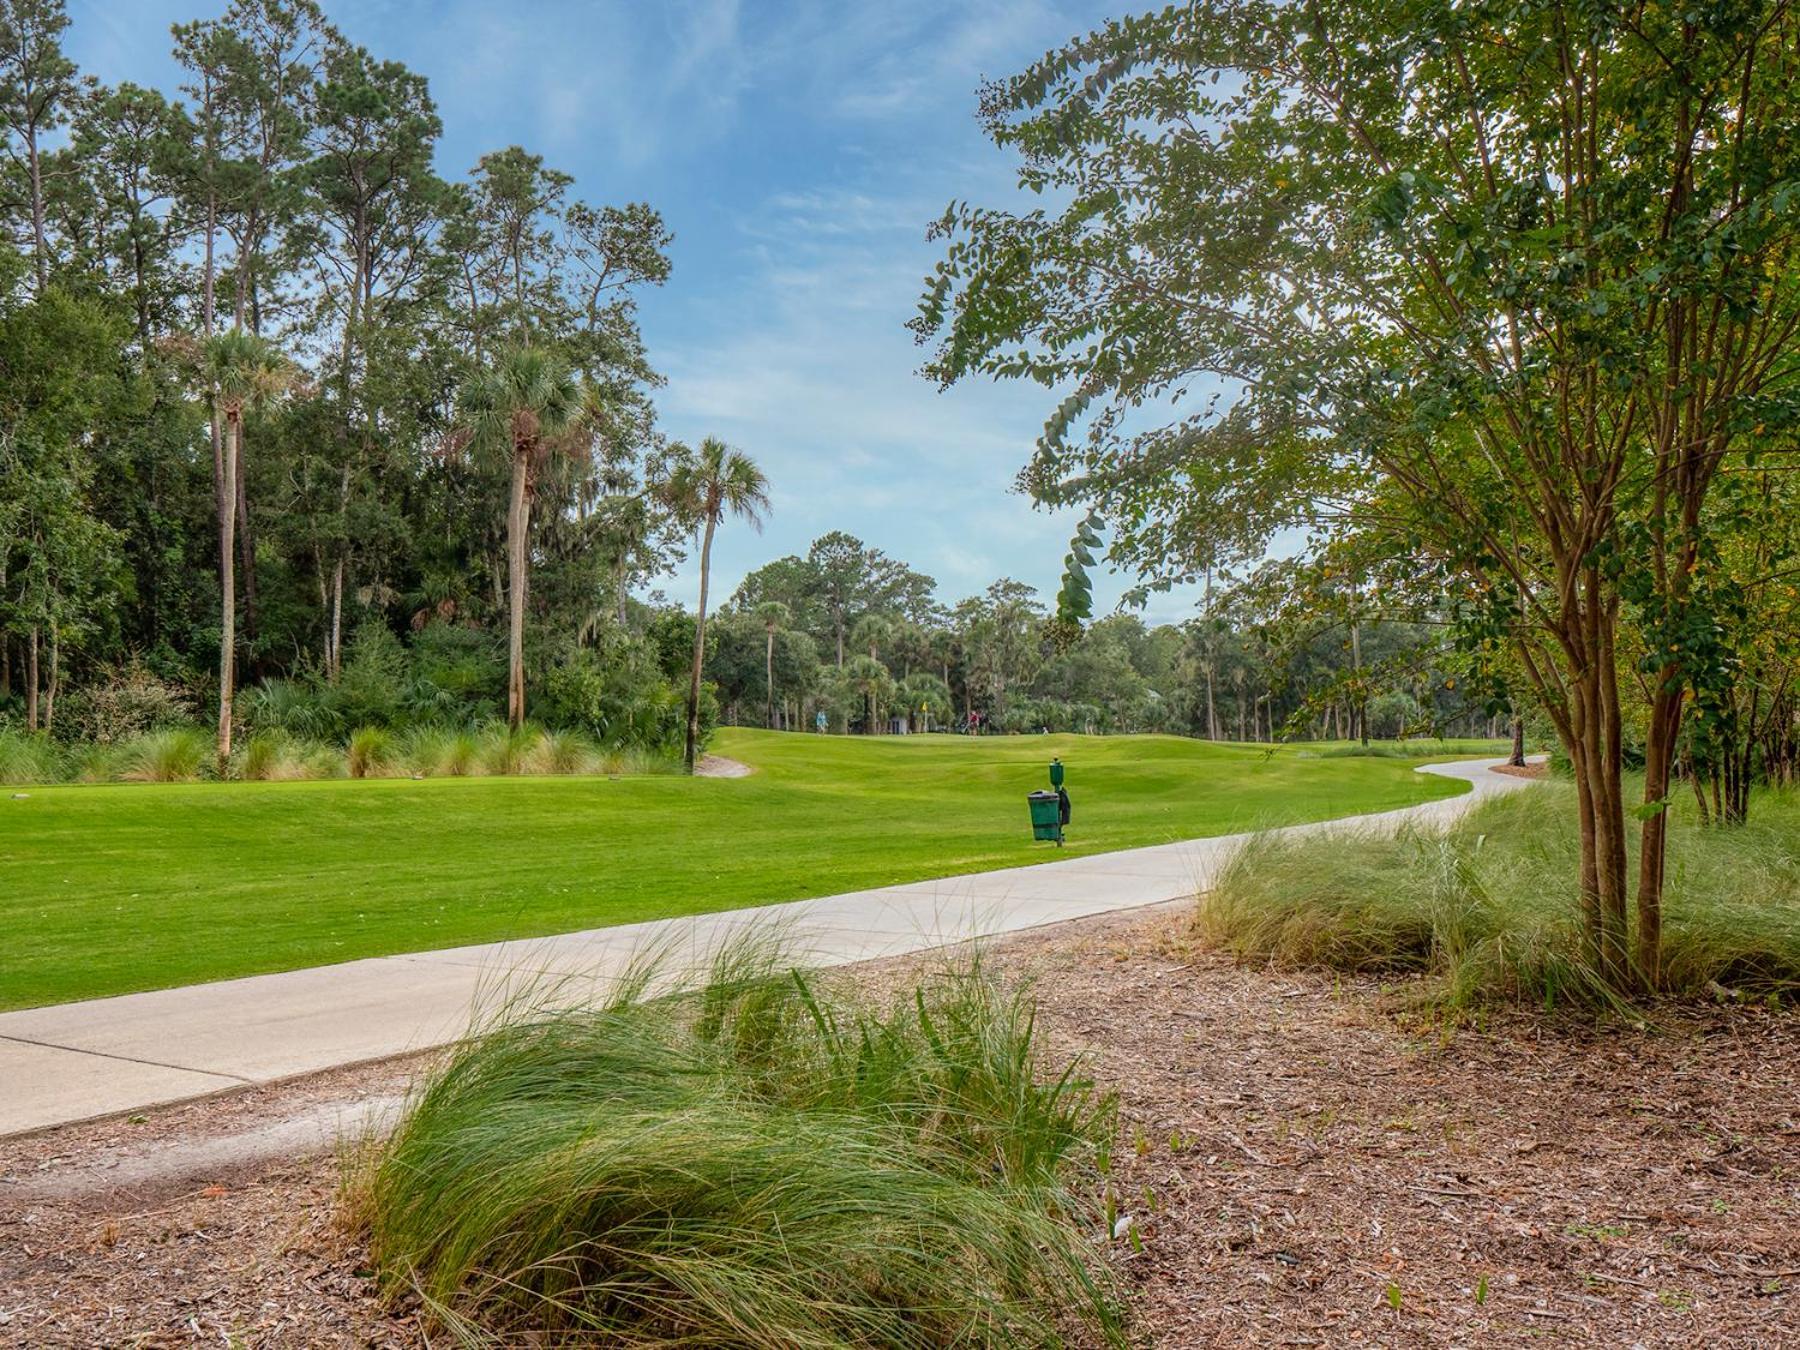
[{"x1": 457, "y1": 347, "x2": 587, "y2": 731}]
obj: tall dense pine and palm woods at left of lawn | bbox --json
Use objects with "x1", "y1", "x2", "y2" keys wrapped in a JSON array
[{"x1": 0, "y1": 0, "x2": 695, "y2": 763}]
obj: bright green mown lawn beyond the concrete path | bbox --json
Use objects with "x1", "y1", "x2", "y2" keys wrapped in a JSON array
[{"x1": 0, "y1": 729, "x2": 1489, "y2": 1008}]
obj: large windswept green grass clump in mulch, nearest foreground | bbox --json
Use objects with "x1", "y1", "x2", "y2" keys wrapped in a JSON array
[{"x1": 349, "y1": 947, "x2": 1123, "y2": 1350}]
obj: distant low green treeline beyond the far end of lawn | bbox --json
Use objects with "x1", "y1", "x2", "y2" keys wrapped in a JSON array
[{"x1": 702, "y1": 531, "x2": 1510, "y2": 742}]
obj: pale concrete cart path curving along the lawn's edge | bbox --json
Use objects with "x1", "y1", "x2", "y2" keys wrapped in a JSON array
[{"x1": 0, "y1": 760, "x2": 1523, "y2": 1136}]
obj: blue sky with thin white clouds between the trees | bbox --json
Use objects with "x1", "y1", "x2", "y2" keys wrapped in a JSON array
[{"x1": 68, "y1": 0, "x2": 1192, "y2": 619}]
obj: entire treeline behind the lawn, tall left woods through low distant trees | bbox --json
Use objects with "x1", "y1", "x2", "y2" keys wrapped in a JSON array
[{"x1": 0, "y1": 0, "x2": 1498, "y2": 776}]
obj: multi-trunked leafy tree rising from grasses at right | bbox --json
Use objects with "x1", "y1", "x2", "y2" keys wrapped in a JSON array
[{"x1": 916, "y1": 0, "x2": 1800, "y2": 985}]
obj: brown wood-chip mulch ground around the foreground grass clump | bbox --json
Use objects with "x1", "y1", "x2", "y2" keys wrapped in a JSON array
[{"x1": 0, "y1": 907, "x2": 1800, "y2": 1348}]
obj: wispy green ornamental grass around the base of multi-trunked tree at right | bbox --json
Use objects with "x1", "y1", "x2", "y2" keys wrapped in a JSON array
[{"x1": 1197, "y1": 783, "x2": 1800, "y2": 1008}]
